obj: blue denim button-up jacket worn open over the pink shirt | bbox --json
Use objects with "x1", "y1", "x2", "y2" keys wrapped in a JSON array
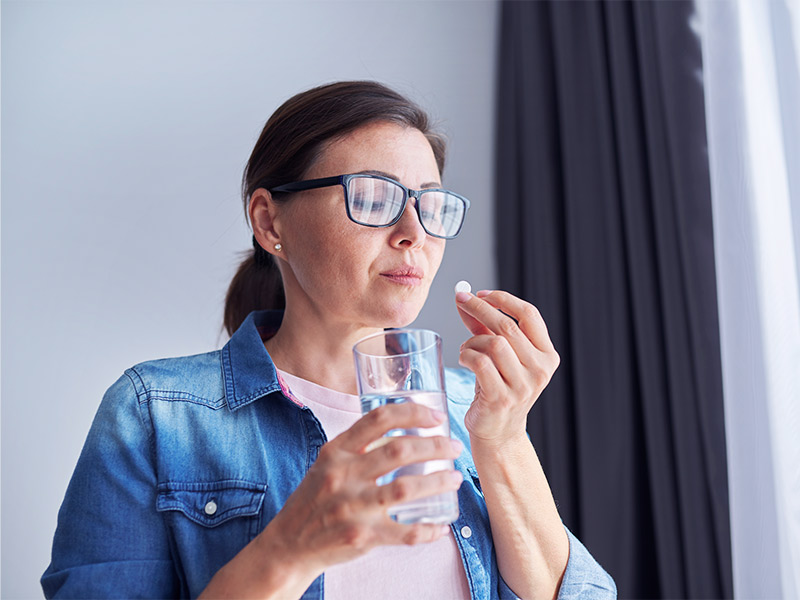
[{"x1": 42, "y1": 311, "x2": 616, "y2": 599}]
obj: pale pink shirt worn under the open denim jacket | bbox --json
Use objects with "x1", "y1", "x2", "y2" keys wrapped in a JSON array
[{"x1": 278, "y1": 370, "x2": 470, "y2": 600}]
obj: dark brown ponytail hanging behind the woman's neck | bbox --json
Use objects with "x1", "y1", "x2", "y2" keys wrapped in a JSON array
[{"x1": 224, "y1": 237, "x2": 286, "y2": 335}]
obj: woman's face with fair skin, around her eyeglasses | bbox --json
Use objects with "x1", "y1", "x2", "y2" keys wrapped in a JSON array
[{"x1": 275, "y1": 122, "x2": 445, "y2": 328}]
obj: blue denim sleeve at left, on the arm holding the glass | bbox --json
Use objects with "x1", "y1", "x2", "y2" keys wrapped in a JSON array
[{"x1": 41, "y1": 374, "x2": 181, "y2": 598}]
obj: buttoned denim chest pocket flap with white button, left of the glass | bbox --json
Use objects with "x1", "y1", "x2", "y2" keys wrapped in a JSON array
[{"x1": 156, "y1": 479, "x2": 267, "y2": 527}]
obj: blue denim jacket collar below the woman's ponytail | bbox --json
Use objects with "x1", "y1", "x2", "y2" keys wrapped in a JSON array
[{"x1": 222, "y1": 310, "x2": 283, "y2": 410}]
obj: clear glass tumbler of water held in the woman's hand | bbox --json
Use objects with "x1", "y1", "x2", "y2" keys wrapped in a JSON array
[{"x1": 353, "y1": 329, "x2": 458, "y2": 524}]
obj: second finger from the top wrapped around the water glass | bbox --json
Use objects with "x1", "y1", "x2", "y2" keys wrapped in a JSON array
[{"x1": 360, "y1": 435, "x2": 464, "y2": 479}]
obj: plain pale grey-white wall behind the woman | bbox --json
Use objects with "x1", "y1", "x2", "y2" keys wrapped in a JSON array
[{"x1": 1, "y1": 0, "x2": 497, "y2": 598}]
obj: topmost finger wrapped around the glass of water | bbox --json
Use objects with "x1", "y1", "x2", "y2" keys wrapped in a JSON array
[{"x1": 333, "y1": 402, "x2": 447, "y2": 452}]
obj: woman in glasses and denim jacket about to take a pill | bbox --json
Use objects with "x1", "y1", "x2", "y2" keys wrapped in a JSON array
[{"x1": 42, "y1": 82, "x2": 615, "y2": 598}]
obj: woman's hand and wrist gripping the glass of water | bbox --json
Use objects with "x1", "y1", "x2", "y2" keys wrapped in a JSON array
[{"x1": 203, "y1": 402, "x2": 462, "y2": 598}]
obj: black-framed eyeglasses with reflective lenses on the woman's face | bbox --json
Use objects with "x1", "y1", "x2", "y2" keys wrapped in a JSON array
[{"x1": 270, "y1": 173, "x2": 469, "y2": 240}]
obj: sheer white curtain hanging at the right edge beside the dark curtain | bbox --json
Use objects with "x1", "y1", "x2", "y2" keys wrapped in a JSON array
[{"x1": 696, "y1": 0, "x2": 800, "y2": 598}]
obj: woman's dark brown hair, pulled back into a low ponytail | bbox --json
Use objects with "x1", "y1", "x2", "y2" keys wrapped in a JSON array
[{"x1": 224, "y1": 81, "x2": 445, "y2": 335}]
